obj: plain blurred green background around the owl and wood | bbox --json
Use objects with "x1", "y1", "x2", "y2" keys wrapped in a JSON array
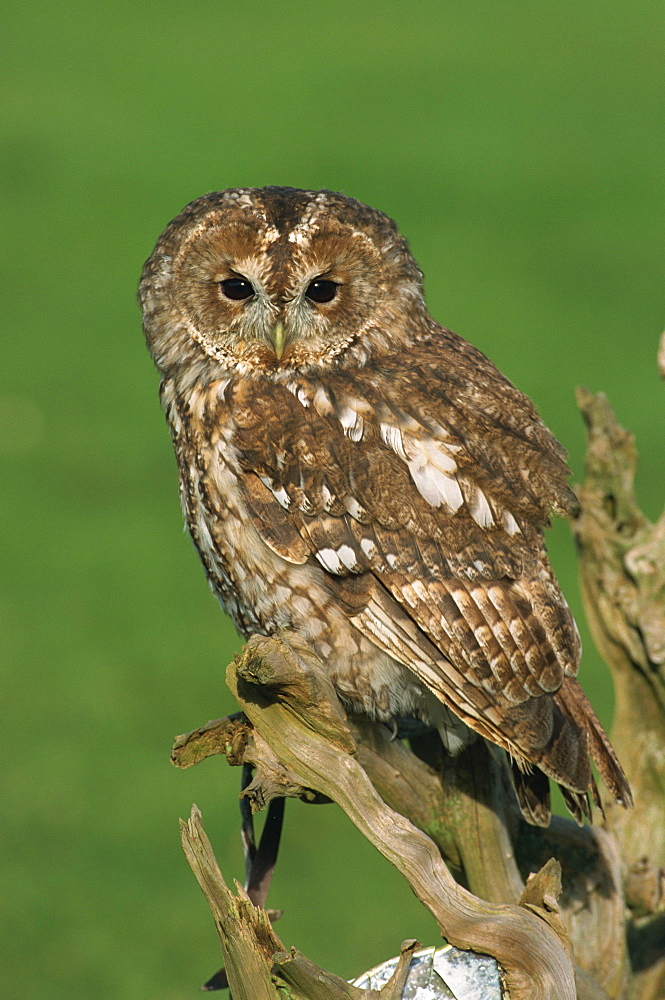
[{"x1": 0, "y1": 0, "x2": 664, "y2": 1000}]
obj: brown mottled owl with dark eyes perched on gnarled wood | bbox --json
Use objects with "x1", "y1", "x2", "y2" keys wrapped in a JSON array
[{"x1": 139, "y1": 187, "x2": 630, "y2": 825}]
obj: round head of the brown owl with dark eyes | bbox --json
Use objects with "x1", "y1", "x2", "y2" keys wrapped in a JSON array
[{"x1": 139, "y1": 187, "x2": 426, "y2": 378}]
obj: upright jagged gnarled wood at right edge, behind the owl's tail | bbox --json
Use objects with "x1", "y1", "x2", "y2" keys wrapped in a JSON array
[{"x1": 575, "y1": 388, "x2": 665, "y2": 1000}]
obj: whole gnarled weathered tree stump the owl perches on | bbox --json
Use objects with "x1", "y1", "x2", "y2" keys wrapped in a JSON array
[{"x1": 172, "y1": 374, "x2": 665, "y2": 1000}]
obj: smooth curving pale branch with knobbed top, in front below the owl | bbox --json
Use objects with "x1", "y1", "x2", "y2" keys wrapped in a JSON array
[{"x1": 227, "y1": 637, "x2": 575, "y2": 1000}]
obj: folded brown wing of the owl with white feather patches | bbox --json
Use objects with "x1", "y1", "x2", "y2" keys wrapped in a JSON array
[{"x1": 227, "y1": 331, "x2": 632, "y2": 808}]
